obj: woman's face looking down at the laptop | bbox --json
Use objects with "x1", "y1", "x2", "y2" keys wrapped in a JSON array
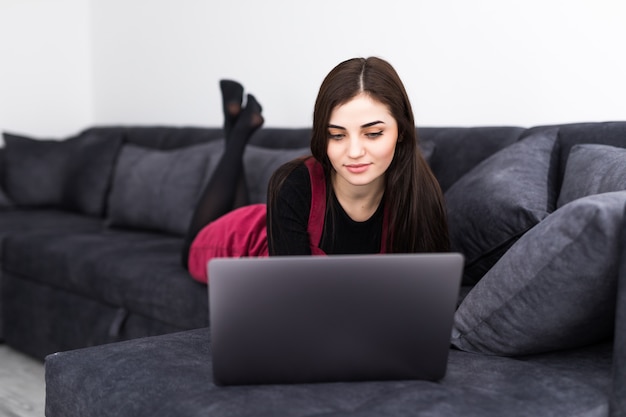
[{"x1": 326, "y1": 94, "x2": 398, "y2": 189}]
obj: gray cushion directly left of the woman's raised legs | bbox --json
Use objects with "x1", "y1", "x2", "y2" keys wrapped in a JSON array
[{"x1": 107, "y1": 140, "x2": 224, "y2": 235}]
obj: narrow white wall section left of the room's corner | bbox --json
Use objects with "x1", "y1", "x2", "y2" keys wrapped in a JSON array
[{"x1": 0, "y1": 0, "x2": 94, "y2": 138}]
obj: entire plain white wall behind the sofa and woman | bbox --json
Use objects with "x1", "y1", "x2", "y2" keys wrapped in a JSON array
[{"x1": 0, "y1": 0, "x2": 626, "y2": 134}]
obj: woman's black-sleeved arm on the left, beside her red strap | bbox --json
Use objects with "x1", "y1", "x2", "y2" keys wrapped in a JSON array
[{"x1": 267, "y1": 164, "x2": 311, "y2": 256}]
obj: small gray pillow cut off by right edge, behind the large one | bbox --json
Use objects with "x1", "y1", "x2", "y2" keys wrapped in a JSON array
[{"x1": 557, "y1": 144, "x2": 626, "y2": 207}]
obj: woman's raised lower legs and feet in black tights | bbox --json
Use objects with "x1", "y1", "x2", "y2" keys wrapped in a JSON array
[{"x1": 181, "y1": 80, "x2": 263, "y2": 268}]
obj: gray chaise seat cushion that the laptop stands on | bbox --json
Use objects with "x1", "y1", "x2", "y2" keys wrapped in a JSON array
[{"x1": 46, "y1": 329, "x2": 611, "y2": 417}]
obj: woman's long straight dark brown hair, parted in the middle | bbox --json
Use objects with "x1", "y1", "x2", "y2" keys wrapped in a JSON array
[{"x1": 268, "y1": 57, "x2": 449, "y2": 253}]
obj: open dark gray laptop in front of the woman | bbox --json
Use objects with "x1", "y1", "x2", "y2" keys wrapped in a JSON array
[{"x1": 208, "y1": 253, "x2": 464, "y2": 385}]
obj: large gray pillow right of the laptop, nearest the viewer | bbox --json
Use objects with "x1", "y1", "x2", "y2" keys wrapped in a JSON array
[{"x1": 452, "y1": 191, "x2": 626, "y2": 356}]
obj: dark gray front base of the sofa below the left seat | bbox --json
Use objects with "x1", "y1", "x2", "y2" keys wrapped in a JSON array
[{"x1": 2, "y1": 272, "x2": 182, "y2": 360}]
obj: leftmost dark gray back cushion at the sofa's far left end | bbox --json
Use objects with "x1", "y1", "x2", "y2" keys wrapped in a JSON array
[{"x1": 3, "y1": 132, "x2": 122, "y2": 216}]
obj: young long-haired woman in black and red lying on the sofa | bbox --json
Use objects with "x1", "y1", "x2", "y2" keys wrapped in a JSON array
[{"x1": 183, "y1": 58, "x2": 449, "y2": 282}]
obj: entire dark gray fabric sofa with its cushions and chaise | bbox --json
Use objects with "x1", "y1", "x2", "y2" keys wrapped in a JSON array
[{"x1": 0, "y1": 122, "x2": 626, "y2": 417}]
